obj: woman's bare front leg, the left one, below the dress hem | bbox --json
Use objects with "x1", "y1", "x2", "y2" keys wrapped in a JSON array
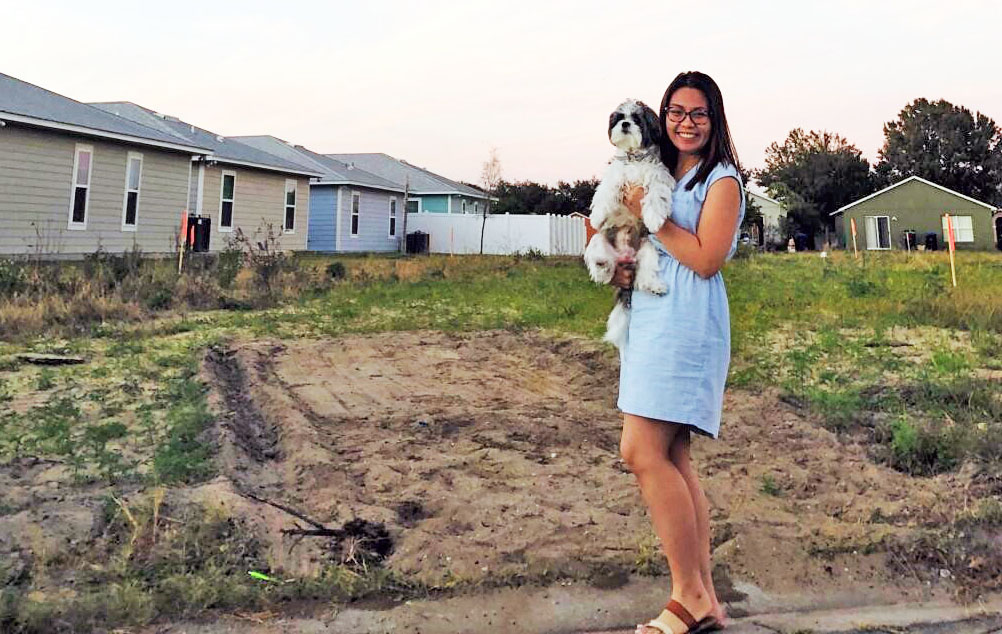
[{"x1": 619, "y1": 414, "x2": 713, "y2": 632}]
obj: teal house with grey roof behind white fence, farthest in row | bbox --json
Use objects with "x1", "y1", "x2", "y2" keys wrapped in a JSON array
[{"x1": 327, "y1": 152, "x2": 489, "y2": 214}]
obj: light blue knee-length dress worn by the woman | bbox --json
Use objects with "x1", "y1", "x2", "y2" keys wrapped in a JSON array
[{"x1": 618, "y1": 163, "x2": 744, "y2": 438}]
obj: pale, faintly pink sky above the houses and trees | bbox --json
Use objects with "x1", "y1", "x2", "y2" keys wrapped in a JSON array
[{"x1": 0, "y1": 0, "x2": 1002, "y2": 185}]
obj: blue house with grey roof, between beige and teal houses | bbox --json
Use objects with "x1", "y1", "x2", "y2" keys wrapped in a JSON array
[{"x1": 235, "y1": 136, "x2": 405, "y2": 252}]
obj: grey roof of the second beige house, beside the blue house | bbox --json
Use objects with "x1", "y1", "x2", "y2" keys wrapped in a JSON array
[{"x1": 90, "y1": 101, "x2": 320, "y2": 176}]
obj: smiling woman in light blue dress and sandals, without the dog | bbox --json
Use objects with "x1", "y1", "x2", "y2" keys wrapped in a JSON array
[{"x1": 613, "y1": 72, "x2": 744, "y2": 634}]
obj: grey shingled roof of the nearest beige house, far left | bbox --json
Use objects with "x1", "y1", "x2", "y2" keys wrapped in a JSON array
[{"x1": 0, "y1": 73, "x2": 208, "y2": 153}]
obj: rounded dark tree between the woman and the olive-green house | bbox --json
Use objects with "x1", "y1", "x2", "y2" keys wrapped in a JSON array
[{"x1": 753, "y1": 128, "x2": 874, "y2": 244}]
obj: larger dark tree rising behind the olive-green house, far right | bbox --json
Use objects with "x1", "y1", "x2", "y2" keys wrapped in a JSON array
[{"x1": 877, "y1": 99, "x2": 1002, "y2": 204}]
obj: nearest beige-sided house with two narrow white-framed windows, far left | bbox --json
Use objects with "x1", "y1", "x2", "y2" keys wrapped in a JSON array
[{"x1": 0, "y1": 74, "x2": 211, "y2": 257}]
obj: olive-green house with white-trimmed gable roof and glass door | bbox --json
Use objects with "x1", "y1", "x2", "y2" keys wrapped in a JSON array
[{"x1": 832, "y1": 176, "x2": 998, "y2": 250}]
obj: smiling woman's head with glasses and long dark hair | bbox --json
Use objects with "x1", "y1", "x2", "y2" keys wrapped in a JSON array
[{"x1": 659, "y1": 71, "x2": 739, "y2": 189}]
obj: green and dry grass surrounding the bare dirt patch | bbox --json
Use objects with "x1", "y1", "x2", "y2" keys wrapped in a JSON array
[{"x1": 0, "y1": 247, "x2": 1002, "y2": 631}]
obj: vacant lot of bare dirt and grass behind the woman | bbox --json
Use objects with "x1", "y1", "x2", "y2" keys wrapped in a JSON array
[{"x1": 0, "y1": 249, "x2": 1002, "y2": 631}]
